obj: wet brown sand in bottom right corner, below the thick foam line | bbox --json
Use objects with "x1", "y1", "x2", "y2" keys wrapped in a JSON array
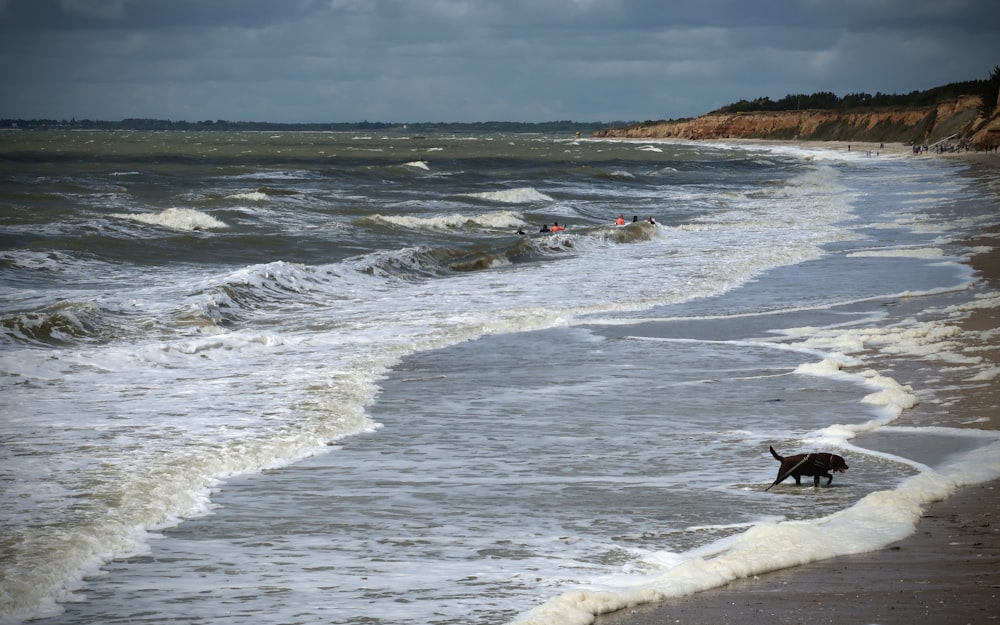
[{"x1": 595, "y1": 480, "x2": 1000, "y2": 625}]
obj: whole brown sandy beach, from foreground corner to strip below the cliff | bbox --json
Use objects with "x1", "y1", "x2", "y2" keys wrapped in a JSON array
[{"x1": 596, "y1": 143, "x2": 1000, "y2": 625}]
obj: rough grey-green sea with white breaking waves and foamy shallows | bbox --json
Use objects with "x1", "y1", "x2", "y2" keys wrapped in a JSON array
[{"x1": 0, "y1": 130, "x2": 1000, "y2": 625}]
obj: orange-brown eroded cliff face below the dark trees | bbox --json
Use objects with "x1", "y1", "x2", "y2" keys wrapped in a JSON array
[{"x1": 595, "y1": 96, "x2": 996, "y2": 143}]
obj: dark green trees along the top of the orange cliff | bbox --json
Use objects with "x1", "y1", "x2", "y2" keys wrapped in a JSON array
[{"x1": 713, "y1": 80, "x2": 984, "y2": 113}]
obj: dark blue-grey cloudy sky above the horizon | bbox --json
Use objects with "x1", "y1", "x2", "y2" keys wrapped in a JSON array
[{"x1": 0, "y1": 0, "x2": 1000, "y2": 122}]
